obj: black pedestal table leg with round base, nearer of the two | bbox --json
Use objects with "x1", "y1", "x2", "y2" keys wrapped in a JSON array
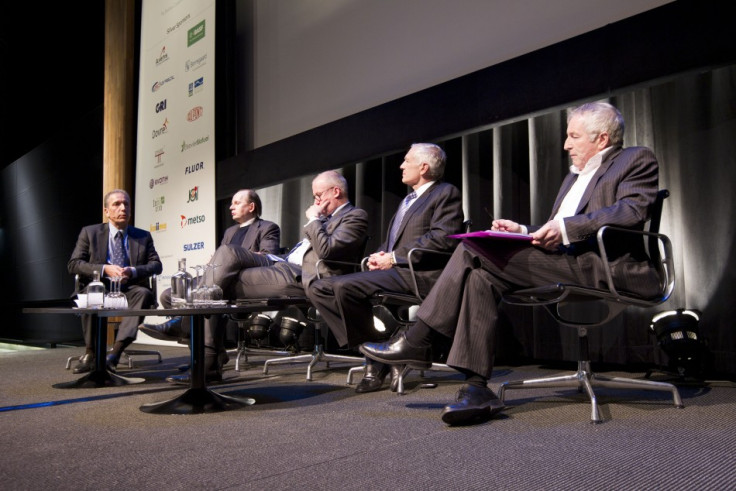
[{"x1": 140, "y1": 314, "x2": 256, "y2": 414}]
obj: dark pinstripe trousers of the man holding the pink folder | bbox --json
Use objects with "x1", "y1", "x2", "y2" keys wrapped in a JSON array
[{"x1": 417, "y1": 241, "x2": 657, "y2": 378}]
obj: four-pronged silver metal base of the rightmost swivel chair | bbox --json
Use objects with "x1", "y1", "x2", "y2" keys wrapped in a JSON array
[{"x1": 498, "y1": 361, "x2": 685, "y2": 423}]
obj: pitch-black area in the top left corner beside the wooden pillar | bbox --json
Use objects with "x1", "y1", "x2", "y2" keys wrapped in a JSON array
[{"x1": 0, "y1": 0, "x2": 105, "y2": 168}]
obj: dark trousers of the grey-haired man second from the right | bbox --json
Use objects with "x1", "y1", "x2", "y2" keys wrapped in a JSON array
[{"x1": 307, "y1": 268, "x2": 410, "y2": 348}]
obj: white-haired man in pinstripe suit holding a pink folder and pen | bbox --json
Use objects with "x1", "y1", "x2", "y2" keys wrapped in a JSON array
[{"x1": 360, "y1": 103, "x2": 658, "y2": 424}]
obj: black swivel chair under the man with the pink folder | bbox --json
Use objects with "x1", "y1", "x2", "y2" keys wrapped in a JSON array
[{"x1": 498, "y1": 189, "x2": 684, "y2": 423}]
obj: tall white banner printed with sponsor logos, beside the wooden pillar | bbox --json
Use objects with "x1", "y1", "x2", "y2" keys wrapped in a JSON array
[{"x1": 134, "y1": 0, "x2": 219, "y2": 300}]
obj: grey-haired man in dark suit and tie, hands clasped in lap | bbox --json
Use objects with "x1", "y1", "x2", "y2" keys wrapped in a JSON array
[{"x1": 307, "y1": 143, "x2": 463, "y2": 392}]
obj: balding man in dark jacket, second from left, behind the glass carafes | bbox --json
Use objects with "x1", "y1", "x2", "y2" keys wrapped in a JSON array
[{"x1": 139, "y1": 189, "x2": 281, "y2": 383}]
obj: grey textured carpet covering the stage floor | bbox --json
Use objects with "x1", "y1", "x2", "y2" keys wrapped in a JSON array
[{"x1": 0, "y1": 346, "x2": 736, "y2": 490}]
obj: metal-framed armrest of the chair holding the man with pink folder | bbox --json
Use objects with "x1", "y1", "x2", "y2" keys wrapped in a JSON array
[{"x1": 596, "y1": 225, "x2": 675, "y2": 303}]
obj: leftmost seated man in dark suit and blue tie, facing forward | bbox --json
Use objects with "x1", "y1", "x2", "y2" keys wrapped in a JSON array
[{"x1": 67, "y1": 189, "x2": 162, "y2": 373}]
